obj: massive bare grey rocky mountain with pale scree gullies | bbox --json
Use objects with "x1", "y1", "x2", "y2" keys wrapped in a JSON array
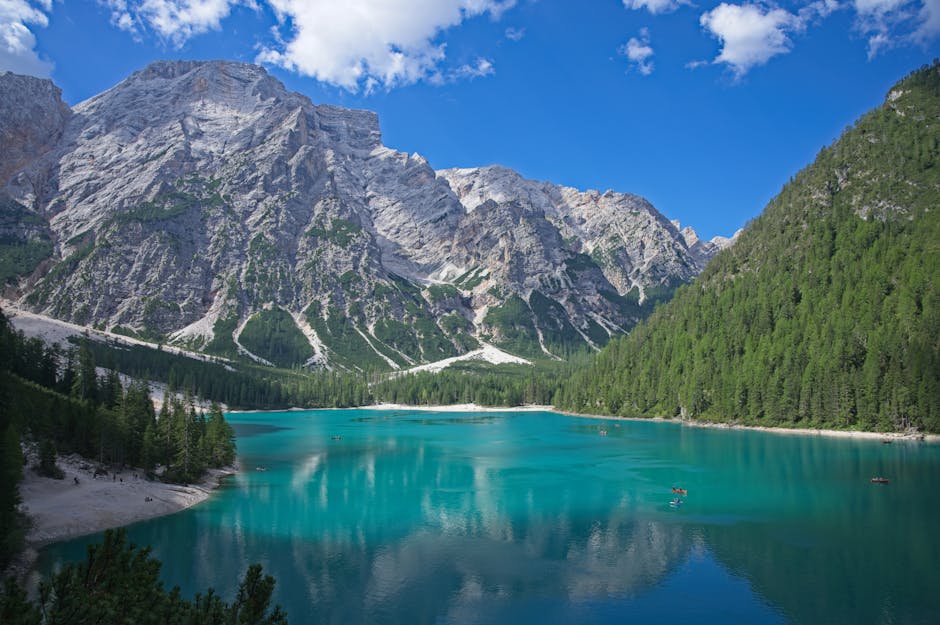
[{"x1": 0, "y1": 62, "x2": 717, "y2": 370}]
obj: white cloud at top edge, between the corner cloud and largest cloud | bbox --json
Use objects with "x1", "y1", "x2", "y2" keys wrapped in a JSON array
[{"x1": 101, "y1": 0, "x2": 239, "y2": 46}]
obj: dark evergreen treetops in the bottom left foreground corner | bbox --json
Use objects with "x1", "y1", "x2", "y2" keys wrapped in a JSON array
[{"x1": 0, "y1": 530, "x2": 287, "y2": 625}]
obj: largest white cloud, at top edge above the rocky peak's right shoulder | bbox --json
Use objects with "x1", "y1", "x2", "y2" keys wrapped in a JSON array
[{"x1": 258, "y1": 0, "x2": 515, "y2": 91}]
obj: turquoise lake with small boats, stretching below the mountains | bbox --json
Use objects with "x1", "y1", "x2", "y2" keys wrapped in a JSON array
[{"x1": 40, "y1": 410, "x2": 940, "y2": 625}]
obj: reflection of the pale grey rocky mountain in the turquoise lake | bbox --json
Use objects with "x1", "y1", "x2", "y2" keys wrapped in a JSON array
[{"x1": 157, "y1": 441, "x2": 698, "y2": 624}]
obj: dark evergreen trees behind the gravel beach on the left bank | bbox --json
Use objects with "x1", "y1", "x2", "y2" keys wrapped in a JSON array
[{"x1": 0, "y1": 313, "x2": 235, "y2": 567}]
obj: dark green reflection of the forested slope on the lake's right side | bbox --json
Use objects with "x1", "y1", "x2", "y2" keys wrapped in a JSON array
[{"x1": 683, "y1": 432, "x2": 940, "y2": 625}]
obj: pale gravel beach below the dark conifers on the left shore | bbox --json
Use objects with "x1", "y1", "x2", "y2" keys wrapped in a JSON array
[{"x1": 7, "y1": 454, "x2": 238, "y2": 579}]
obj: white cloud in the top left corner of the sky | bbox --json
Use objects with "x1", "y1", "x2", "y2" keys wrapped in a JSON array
[{"x1": 0, "y1": 0, "x2": 52, "y2": 78}]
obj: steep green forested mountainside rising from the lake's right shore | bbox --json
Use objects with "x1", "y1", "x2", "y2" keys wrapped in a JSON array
[{"x1": 559, "y1": 62, "x2": 940, "y2": 432}]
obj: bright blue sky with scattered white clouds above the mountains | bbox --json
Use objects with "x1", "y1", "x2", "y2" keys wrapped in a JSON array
[{"x1": 0, "y1": 0, "x2": 940, "y2": 238}]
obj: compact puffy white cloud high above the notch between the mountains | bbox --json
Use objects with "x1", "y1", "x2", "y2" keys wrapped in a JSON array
[{"x1": 699, "y1": 3, "x2": 808, "y2": 78}]
